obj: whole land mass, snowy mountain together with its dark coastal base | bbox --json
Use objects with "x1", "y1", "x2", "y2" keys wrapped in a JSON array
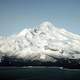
[{"x1": 0, "y1": 21, "x2": 80, "y2": 69}]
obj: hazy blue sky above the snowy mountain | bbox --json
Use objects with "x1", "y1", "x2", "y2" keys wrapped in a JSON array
[{"x1": 0, "y1": 0, "x2": 80, "y2": 35}]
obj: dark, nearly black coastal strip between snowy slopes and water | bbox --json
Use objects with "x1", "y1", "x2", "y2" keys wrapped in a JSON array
[{"x1": 0, "y1": 56, "x2": 80, "y2": 69}]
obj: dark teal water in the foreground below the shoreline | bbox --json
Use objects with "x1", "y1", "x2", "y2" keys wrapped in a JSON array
[{"x1": 0, "y1": 67, "x2": 80, "y2": 80}]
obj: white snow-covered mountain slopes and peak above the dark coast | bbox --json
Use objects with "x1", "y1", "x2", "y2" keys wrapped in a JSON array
[{"x1": 0, "y1": 22, "x2": 80, "y2": 61}]
